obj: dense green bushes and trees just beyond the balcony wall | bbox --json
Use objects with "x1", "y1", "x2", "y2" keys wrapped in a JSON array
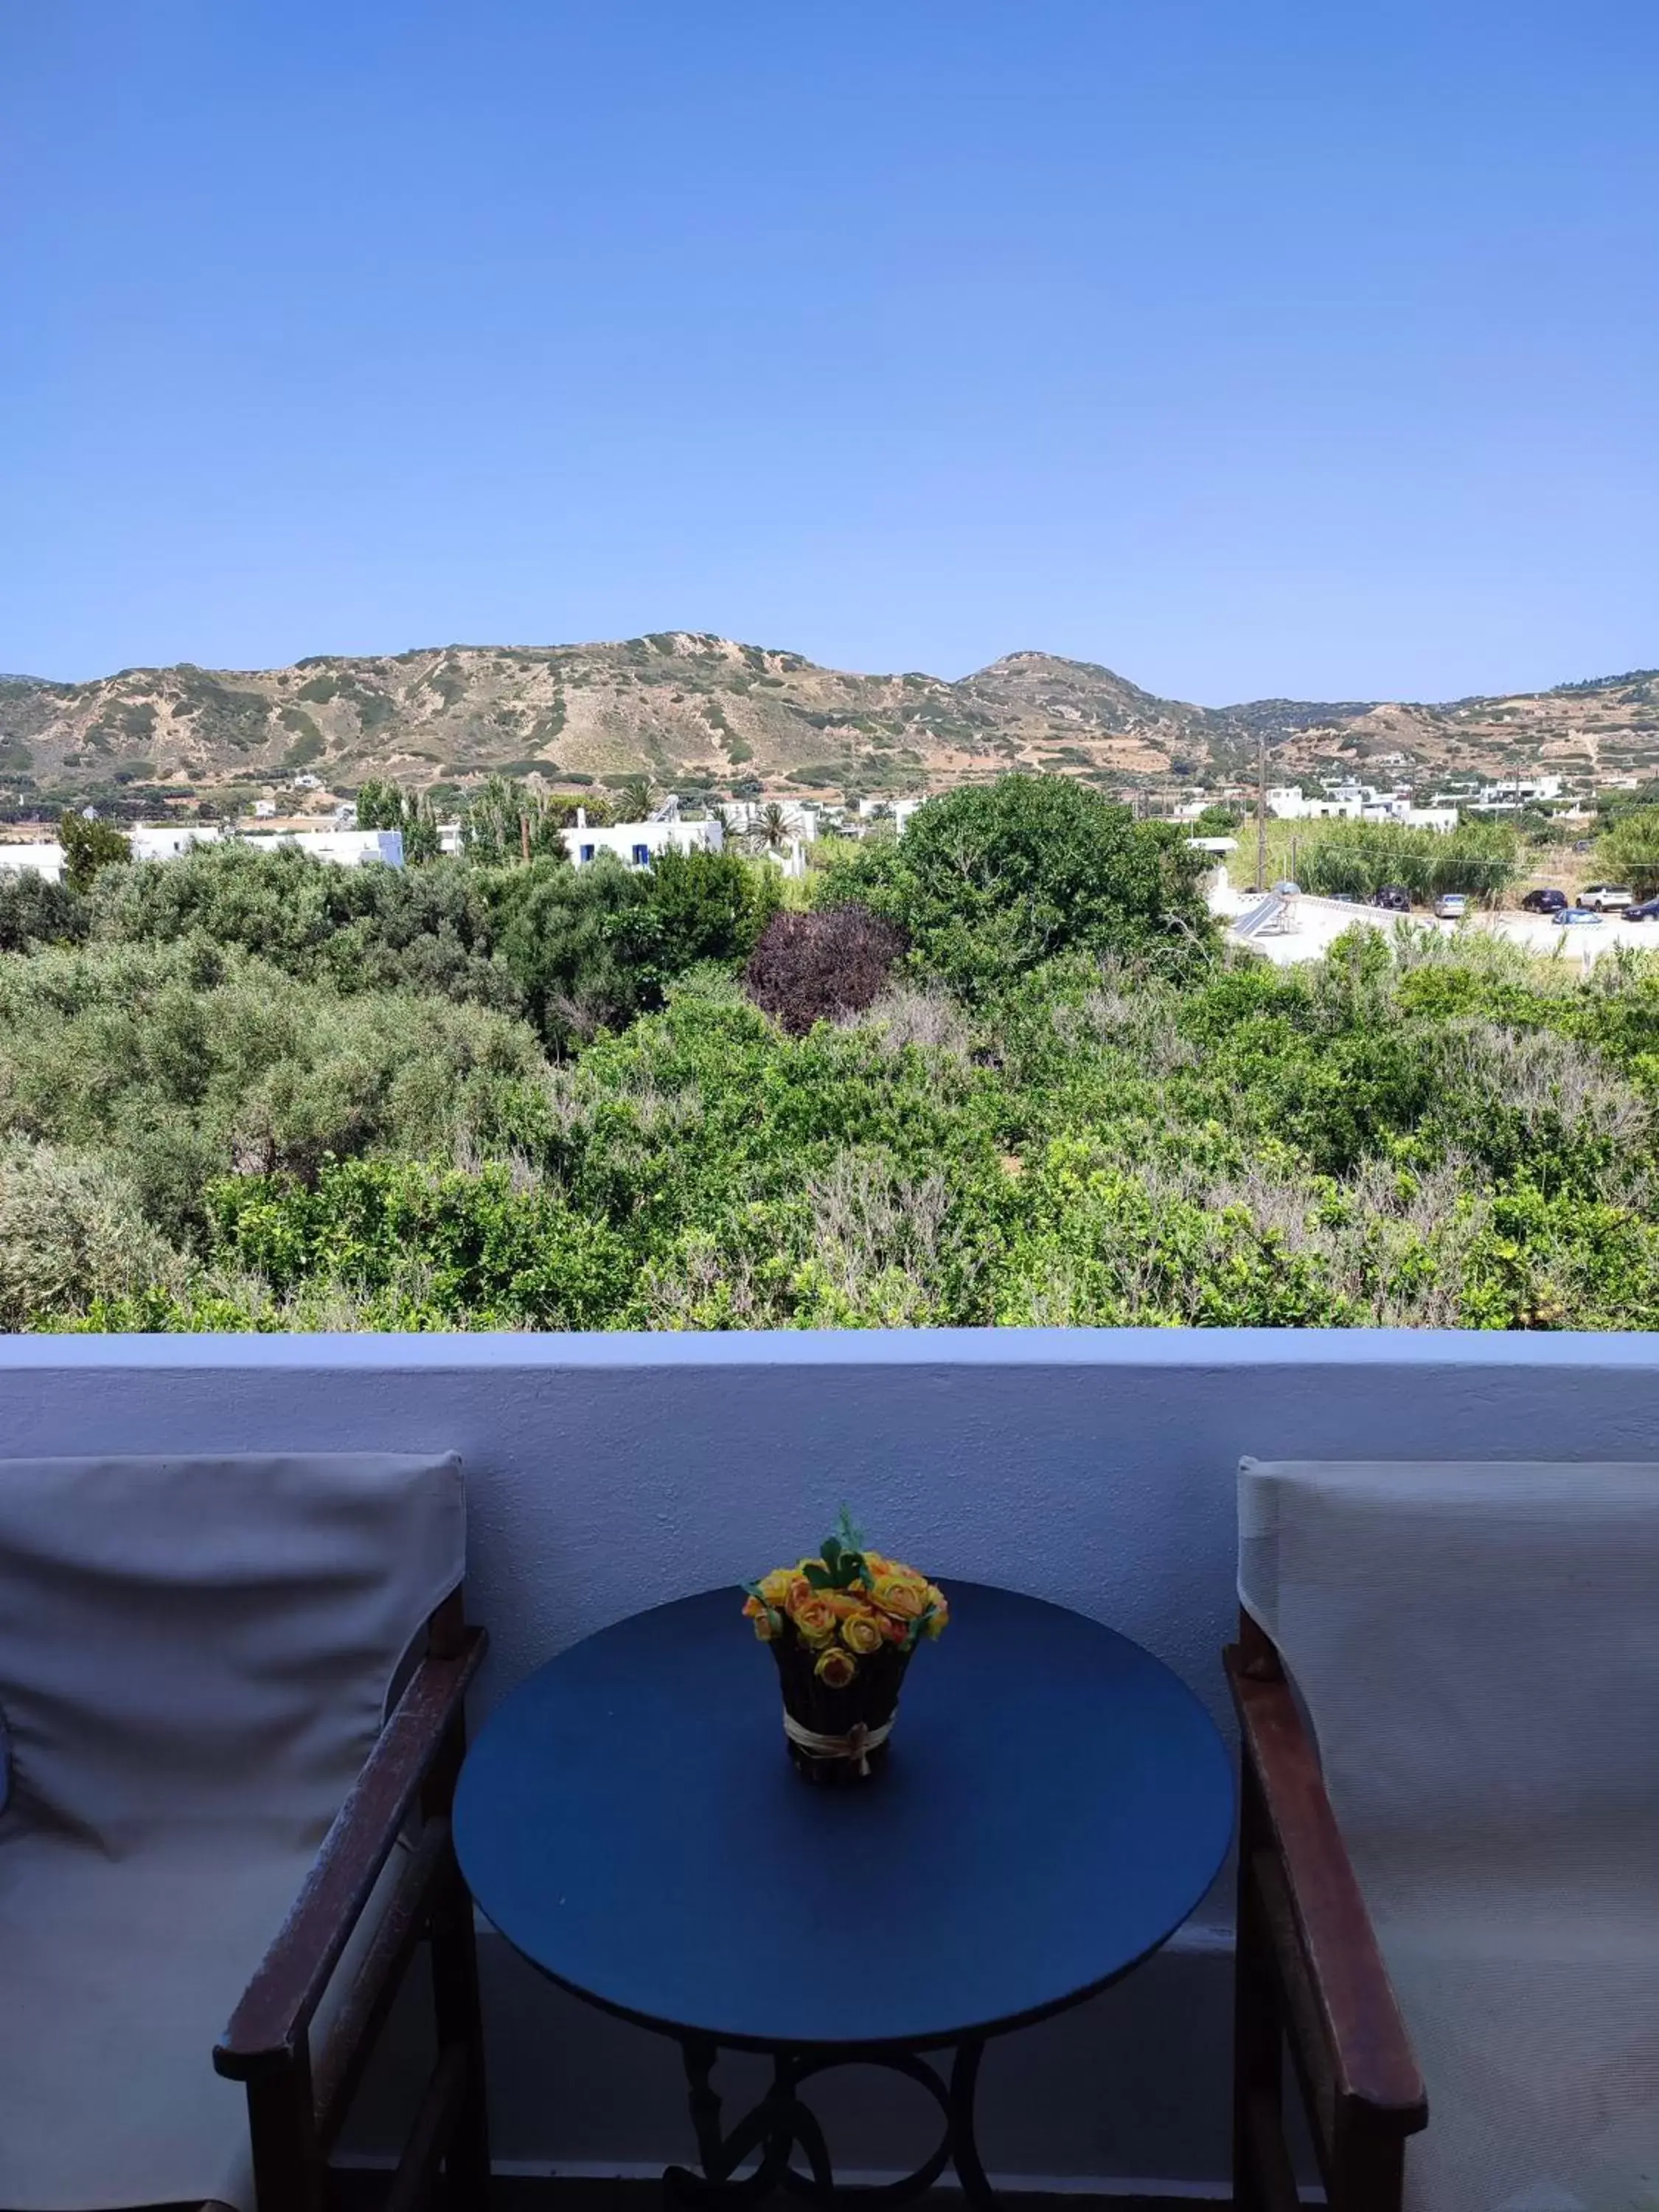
[{"x1": 0, "y1": 776, "x2": 1659, "y2": 1329}]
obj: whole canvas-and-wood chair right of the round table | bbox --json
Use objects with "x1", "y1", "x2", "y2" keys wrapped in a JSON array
[{"x1": 1225, "y1": 1460, "x2": 1659, "y2": 2212}]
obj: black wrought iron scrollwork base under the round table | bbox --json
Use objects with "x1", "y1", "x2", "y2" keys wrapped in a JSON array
[{"x1": 664, "y1": 2037, "x2": 998, "y2": 2212}]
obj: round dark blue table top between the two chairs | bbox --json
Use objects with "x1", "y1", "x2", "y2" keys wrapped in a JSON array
[{"x1": 453, "y1": 1582, "x2": 1232, "y2": 2048}]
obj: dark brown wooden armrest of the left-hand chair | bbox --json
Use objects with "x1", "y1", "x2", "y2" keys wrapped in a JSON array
[{"x1": 212, "y1": 1628, "x2": 484, "y2": 2081}]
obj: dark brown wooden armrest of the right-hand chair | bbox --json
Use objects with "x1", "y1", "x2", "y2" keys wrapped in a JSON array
[{"x1": 1225, "y1": 1639, "x2": 1429, "y2": 2135}]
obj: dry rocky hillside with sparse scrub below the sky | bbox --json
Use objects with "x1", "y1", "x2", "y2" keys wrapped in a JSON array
[{"x1": 0, "y1": 630, "x2": 1659, "y2": 801}]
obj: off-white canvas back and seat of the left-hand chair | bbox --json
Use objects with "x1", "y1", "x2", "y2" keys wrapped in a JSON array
[{"x1": 0, "y1": 1453, "x2": 465, "y2": 2212}]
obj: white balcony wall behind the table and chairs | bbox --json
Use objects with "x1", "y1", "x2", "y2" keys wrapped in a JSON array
[{"x1": 0, "y1": 1329, "x2": 1659, "y2": 2194}]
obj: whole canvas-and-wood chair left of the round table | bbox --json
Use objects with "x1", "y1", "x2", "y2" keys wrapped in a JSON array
[{"x1": 0, "y1": 1453, "x2": 489, "y2": 2212}]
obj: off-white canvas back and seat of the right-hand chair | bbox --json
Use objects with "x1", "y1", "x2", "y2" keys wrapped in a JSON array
[{"x1": 1239, "y1": 1460, "x2": 1659, "y2": 2212}]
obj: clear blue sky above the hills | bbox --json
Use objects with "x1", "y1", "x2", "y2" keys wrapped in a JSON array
[{"x1": 0, "y1": 0, "x2": 1659, "y2": 703}]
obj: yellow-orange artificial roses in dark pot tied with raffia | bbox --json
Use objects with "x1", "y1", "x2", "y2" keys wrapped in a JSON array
[{"x1": 743, "y1": 1506, "x2": 951, "y2": 1783}]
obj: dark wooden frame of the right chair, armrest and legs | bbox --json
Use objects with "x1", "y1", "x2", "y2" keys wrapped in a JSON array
[{"x1": 1223, "y1": 1610, "x2": 1429, "y2": 2212}]
